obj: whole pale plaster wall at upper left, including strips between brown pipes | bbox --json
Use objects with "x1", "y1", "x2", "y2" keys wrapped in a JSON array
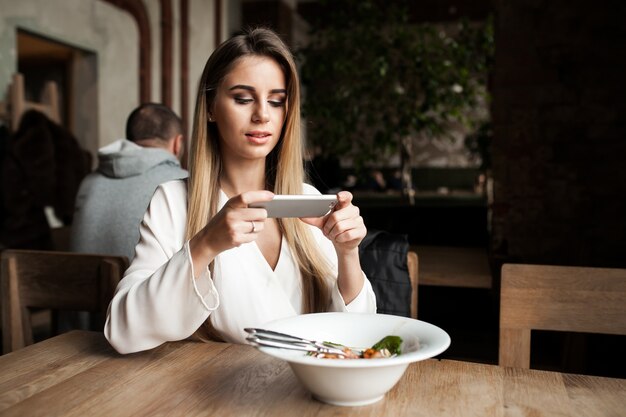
[{"x1": 0, "y1": 0, "x2": 217, "y2": 153}]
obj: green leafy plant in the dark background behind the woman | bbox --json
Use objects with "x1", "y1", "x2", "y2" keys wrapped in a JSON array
[{"x1": 298, "y1": 0, "x2": 493, "y2": 172}]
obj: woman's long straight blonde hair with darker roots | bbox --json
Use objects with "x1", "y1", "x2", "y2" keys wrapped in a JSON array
[{"x1": 186, "y1": 28, "x2": 331, "y2": 318}]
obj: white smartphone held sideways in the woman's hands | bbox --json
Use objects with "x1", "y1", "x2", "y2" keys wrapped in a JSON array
[{"x1": 249, "y1": 194, "x2": 337, "y2": 217}]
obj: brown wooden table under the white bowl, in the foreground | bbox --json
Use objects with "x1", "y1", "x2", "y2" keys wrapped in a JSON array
[{"x1": 0, "y1": 331, "x2": 626, "y2": 417}]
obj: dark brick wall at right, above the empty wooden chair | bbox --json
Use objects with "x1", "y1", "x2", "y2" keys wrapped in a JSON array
[{"x1": 492, "y1": 0, "x2": 626, "y2": 267}]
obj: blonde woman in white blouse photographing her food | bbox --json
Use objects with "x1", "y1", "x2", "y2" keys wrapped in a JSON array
[{"x1": 105, "y1": 29, "x2": 376, "y2": 353}]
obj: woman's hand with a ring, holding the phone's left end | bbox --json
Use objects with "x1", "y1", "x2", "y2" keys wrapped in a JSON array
[{"x1": 189, "y1": 190, "x2": 274, "y2": 271}]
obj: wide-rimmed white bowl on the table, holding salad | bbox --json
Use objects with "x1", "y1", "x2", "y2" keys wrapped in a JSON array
[{"x1": 254, "y1": 313, "x2": 450, "y2": 406}]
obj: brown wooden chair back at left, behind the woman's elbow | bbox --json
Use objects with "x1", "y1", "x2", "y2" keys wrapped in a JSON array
[{"x1": 0, "y1": 249, "x2": 128, "y2": 353}]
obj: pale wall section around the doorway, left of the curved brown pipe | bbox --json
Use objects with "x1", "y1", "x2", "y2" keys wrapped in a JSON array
[{"x1": 0, "y1": 0, "x2": 138, "y2": 155}]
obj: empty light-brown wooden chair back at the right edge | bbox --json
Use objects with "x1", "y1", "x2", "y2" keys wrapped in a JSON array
[{"x1": 498, "y1": 264, "x2": 626, "y2": 368}]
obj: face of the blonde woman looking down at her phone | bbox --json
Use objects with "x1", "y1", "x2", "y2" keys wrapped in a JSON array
[{"x1": 210, "y1": 57, "x2": 287, "y2": 160}]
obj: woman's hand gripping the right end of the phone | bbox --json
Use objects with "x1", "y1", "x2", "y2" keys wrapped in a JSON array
[{"x1": 301, "y1": 191, "x2": 367, "y2": 253}]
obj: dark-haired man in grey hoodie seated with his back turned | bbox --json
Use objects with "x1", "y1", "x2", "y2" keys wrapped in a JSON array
[{"x1": 70, "y1": 103, "x2": 187, "y2": 260}]
